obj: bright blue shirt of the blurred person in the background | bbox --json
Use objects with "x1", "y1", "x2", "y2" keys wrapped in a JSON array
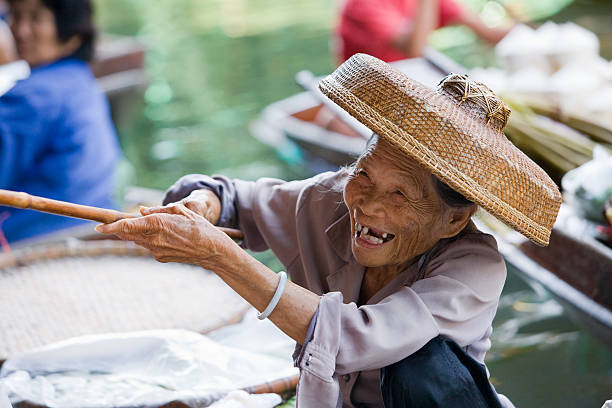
[{"x1": 0, "y1": 59, "x2": 119, "y2": 242}]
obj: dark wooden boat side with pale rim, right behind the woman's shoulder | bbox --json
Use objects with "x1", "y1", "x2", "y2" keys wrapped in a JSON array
[{"x1": 476, "y1": 212, "x2": 612, "y2": 348}]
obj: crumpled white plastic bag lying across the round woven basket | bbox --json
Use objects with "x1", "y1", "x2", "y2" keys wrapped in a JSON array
[{"x1": 0, "y1": 312, "x2": 298, "y2": 408}]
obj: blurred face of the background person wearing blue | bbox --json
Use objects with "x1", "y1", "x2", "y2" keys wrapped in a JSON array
[{"x1": 9, "y1": 0, "x2": 73, "y2": 67}]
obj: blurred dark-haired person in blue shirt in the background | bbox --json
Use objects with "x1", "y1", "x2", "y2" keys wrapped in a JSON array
[{"x1": 0, "y1": 0, "x2": 120, "y2": 242}]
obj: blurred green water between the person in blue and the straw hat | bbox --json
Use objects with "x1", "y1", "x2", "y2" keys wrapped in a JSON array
[{"x1": 98, "y1": 0, "x2": 334, "y2": 188}]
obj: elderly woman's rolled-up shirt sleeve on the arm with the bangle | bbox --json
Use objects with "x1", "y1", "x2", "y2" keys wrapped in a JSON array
[{"x1": 297, "y1": 234, "x2": 505, "y2": 381}]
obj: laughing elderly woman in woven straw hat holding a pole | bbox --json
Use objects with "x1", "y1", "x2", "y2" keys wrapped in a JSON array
[{"x1": 99, "y1": 54, "x2": 560, "y2": 407}]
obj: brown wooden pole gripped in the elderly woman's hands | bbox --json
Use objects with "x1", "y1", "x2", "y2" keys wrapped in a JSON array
[{"x1": 0, "y1": 189, "x2": 243, "y2": 239}]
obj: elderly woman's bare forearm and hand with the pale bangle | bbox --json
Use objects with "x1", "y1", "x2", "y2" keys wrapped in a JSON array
[{"x1": 96, "y1": 204, "x2": 319, "y2": 344}]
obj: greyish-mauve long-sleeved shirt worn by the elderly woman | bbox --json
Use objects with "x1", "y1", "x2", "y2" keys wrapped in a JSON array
[{"x1": 165, "y1": 171, "x2": 512, "y2": 407}]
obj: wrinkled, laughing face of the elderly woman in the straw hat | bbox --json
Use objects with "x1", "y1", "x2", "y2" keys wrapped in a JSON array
[{"x1": 344, "y1": 142, "x2": 448, "y2": 269}]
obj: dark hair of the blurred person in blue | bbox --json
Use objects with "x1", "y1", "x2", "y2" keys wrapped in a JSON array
[{"x1": 8, "y1": 0, "x2": 97, "y2": 62}]
